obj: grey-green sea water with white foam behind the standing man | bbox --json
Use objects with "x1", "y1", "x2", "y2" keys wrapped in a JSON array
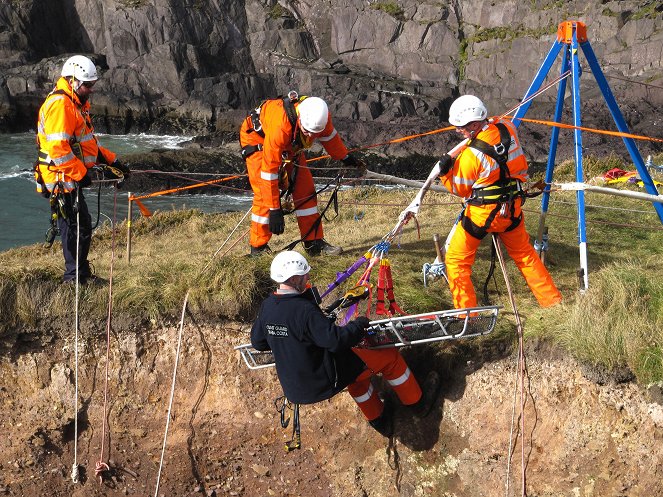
[{"x1": 0, "y1": 133, "x2": 252, "y2": 251}]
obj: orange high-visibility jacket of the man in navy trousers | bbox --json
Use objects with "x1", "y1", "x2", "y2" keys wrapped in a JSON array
[{"x1": 37, "y1": 78, "x2": 115, "y2": 191}]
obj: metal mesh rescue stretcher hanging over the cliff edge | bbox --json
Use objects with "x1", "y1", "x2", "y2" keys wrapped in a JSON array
[{"x1": 235, "y1": 306, "x2": 501, "y2": 369}]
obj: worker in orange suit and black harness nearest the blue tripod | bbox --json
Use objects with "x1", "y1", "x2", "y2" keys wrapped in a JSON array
[{"x1": 404, "y1": 95, "x2": 562, "y2": 308}]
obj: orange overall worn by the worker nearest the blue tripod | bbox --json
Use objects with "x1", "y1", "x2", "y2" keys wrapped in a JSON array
[{"x1": 441, "y1": 121, "x2": 562, "y2": 308}]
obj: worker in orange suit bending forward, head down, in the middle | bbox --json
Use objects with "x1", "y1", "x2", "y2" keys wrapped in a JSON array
[{"x1": 239, "y1": 92, "x2": 365, "y2": 256}]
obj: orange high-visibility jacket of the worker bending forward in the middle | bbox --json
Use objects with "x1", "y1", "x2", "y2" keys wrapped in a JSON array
[{"x1": 240, "y1": 98, "x2": 348, "y2": 209}]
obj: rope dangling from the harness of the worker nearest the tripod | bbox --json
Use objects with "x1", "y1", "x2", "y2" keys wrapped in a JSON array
[{"x1": 492, "y1": 234, "x2": 527, "y2": 497}]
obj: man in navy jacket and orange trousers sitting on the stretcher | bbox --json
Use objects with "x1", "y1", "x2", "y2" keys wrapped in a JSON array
[{"x1": 251, "y1": 250, "x2": 439, "y2": 436}]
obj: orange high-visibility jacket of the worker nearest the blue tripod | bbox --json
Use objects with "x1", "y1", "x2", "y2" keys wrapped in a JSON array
[{"x1": 440, "y1": 120, "x2": 529, "y2": 198}]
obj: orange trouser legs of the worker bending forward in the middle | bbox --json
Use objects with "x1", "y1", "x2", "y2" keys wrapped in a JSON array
[{"x1": 246, "y1": 151, "x2": 324, "y2": 247}]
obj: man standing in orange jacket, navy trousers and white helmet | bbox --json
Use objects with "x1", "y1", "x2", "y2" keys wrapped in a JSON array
[{"x1": 35, "y1": 55, "x2": 129, "y2": 283}]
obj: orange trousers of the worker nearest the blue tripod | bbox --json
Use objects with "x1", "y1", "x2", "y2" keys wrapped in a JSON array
[{"x1": 445, "y1": 206, "x2": 562, "y2": 309}]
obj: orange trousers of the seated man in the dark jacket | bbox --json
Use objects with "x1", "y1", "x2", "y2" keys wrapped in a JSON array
[{"x1": 348, "y1": 348, "x2": 421, "y2": 421}]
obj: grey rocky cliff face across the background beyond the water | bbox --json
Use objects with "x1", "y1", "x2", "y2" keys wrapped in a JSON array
[{"x1": 0, "y1": 0, "x2": 663, "y2": 155}]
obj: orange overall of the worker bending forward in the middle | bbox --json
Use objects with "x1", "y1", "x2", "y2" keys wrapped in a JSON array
[{"x1": 239, "y1": 97, "x2": 348, "y2": 247}]
